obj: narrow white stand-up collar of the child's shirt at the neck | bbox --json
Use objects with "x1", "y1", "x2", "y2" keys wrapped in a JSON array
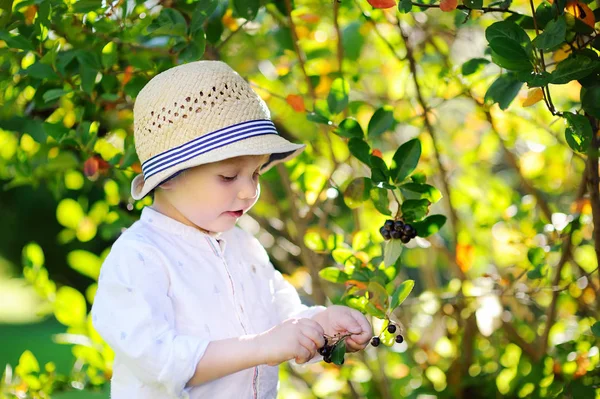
[{"x1": 140, "y1": 206, "x2": 226, "y2": 252}]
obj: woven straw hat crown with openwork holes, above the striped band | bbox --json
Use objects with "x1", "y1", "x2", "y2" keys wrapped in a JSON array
[{"x1": 133, "y1": 60, "x2": 271, "y2": 163}]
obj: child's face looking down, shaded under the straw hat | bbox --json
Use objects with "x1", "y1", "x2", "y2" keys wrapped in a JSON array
[{"x1": 161, "y1": 155, "x2": 269, "y2": 232}]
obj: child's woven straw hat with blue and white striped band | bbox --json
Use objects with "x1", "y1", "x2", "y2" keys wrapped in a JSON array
[{"x1": 131, "y1": 60, "x2": 306, "y2": 200}]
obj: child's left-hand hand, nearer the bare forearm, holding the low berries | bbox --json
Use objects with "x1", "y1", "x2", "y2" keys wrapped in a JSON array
[{"x1": 257, "y1": 319, "x2": 325, "y2": 366}]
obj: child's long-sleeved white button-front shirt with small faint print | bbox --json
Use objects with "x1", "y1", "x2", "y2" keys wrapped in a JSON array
[{"x1": 91, "y1": 207, "x2": 325, "y2": 399}]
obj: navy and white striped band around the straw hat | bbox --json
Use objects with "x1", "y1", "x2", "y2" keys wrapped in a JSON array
[{"x1": 142, "y1": 119, "x2": 278, "y2": 180}]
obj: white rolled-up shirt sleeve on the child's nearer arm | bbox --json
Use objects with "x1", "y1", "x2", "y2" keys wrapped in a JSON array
[{"x1": 91, "y1": 241, "x2": 209, "y2": 398}]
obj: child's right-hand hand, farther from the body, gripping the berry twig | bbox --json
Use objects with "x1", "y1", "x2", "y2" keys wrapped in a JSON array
[{"x1": 313, "y1": 305, "x2": 373, "y2": 352}]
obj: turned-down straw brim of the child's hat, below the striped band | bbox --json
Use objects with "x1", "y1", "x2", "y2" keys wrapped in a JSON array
[{"x1": 131, "y1": 135, "x2": 306, "y2": 200}]
